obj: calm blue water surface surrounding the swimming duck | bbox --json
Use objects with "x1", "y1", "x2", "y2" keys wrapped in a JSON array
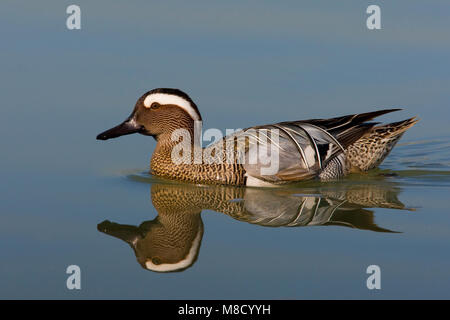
[{"x1": 0, "y1": 0, "x2": 450, "y2": 299}]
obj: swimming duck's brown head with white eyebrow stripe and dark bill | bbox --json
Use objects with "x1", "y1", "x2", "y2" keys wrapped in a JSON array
[{"x1": 97, "y1": 88, "x2": 202, "y2": 140}]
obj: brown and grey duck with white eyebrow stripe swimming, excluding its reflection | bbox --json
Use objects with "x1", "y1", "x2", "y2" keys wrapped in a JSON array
[{"x1": 97, "y1": 88, "x2": 418, "y2": 186}]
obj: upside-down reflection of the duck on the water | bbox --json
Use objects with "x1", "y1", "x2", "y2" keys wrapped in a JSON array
[{"x1": 97, "y1": 182, "x2": 411, "y2": 272}]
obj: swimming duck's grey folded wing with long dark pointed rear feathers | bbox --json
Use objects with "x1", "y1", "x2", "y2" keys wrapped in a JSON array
[{"x1": 216, "y1": 109, "x2": 397, "y2": 183}]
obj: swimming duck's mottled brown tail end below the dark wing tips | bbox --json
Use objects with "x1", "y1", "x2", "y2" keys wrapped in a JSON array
[{"x1": 346, "y1": 117, "x2": 419, "y2": 171}]
